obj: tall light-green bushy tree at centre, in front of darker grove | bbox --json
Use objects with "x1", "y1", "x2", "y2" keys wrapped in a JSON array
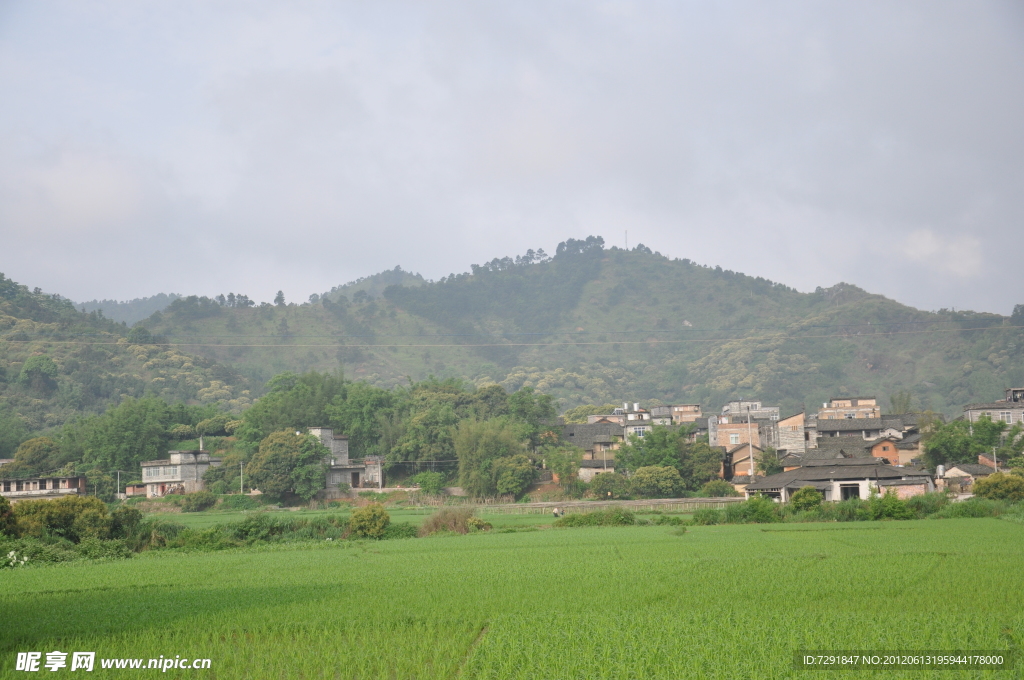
[{"x1": 455, "y1": 418, "x2": 528, "y2": 497}]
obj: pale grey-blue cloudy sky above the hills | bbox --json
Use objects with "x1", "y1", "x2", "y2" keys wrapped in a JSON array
[{"x1": 0, "y1": 0, "x2": 1024, "y2": 314}]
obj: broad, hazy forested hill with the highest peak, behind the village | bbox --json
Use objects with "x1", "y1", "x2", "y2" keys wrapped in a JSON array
[{"x1": 142, "y1": 237, "x2": 1024, "y2": 415}]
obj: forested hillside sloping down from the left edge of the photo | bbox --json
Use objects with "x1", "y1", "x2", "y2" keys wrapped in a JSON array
[{"x1": 0, "y1": 274, "x2": 250, "y2": 458}]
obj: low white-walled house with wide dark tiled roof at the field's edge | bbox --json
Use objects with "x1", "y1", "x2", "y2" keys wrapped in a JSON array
[{"x1": 744, "y1": 458, "x2": 935, "y2": 503}]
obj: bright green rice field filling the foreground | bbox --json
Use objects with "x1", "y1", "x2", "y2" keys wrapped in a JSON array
[{"x1": 0, "y1": 517, "x2": 1024, "y2": 679}]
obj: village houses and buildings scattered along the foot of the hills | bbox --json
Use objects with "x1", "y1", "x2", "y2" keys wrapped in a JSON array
[{"x1": 0, "y1": 388, "x2": 1024, "y2": 503}]
